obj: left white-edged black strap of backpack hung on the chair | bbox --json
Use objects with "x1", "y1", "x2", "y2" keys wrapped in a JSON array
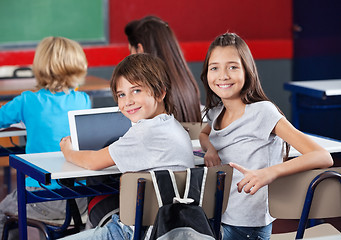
[{"x1": 150, "y1": 170, "x2": 180, "y2": 207}]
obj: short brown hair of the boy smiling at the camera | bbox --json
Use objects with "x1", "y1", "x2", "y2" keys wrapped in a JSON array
[{"x1": 110, "y1": 53, "x2": 175, "y2": 114}]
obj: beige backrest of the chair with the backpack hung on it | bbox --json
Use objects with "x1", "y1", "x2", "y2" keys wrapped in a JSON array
[{"x1": 120, "y1": 165, "x2": 233, "y2": 226}]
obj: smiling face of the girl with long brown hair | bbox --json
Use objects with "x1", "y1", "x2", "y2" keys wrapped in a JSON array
[{"x1": 207, "y1": 46, "x2": 245, "y2": 101}]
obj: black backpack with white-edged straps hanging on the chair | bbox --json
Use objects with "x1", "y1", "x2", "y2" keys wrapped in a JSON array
[{"x1": 150, "y1": 167, "x2": 215, "y2": 240}]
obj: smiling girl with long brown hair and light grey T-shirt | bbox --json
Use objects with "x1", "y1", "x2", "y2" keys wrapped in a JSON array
[{"x1": 199, "y1": 33, "x2": 333, "y2": 240}]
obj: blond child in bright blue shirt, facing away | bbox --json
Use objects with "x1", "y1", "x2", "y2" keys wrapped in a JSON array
[{"x1": 0, "y1": 37, "x2": 91, "y2": 239}]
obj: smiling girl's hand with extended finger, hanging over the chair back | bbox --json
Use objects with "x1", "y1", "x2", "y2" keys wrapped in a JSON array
[{"x1": 230, "y1": 162, "x2": 276, "y2": 195}]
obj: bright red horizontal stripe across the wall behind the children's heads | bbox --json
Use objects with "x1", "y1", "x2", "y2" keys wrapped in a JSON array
[{"x1": 0, "y1": 40, "x2": 293, "y2": 67}]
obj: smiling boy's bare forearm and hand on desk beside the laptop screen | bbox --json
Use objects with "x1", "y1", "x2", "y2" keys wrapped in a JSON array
[{"x1": 60, "y1": 136, "x2": 115, "y2": 170}]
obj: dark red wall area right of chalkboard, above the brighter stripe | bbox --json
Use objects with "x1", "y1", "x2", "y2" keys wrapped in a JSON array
[{"x1": 109, "y1": 0, "x2": 292, "y2": 43}]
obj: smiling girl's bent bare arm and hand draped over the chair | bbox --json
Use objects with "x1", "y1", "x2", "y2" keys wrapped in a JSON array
[{"x1": 230, "y1": 118, "x2": 333, "y2": 194}]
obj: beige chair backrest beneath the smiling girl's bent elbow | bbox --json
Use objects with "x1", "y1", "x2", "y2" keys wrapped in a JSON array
[{"x1": 269, "y1": 167, "x2": 341, "y2": 219}]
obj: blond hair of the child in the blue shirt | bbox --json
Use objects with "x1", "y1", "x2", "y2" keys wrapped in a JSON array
[{"x1": 32, "y1": 37, "x2": 88, "y2": 93}]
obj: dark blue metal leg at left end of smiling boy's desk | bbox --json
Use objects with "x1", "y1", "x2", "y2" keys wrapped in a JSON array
[{"x1": 17, "y1": 171, "x2": 27, "y2": 240}]
